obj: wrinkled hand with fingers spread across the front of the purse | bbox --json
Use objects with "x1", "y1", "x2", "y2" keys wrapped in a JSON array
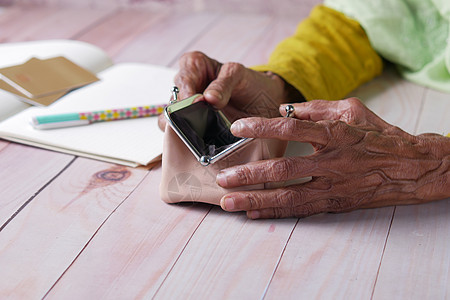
[{"x1": 217, "y1": 98, "x2": 450, "y2": 218}]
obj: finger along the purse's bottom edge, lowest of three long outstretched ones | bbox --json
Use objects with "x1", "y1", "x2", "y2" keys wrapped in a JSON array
[{"x1": 220, "y1": 179, "x2": 331, "y2": 211}]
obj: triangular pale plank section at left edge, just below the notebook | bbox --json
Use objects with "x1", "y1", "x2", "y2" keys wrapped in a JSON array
[{"x1": 0, "y1": 141, "x2": 73, "y2": 228}]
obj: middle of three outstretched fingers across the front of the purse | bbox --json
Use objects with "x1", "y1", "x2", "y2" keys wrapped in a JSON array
[{"x1": 216, "y1": 155, "x2": 325, "y2": 188}]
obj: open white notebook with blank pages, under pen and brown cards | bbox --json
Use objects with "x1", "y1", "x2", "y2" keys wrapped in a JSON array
[{"x1": 0, "y1": 40, "x2": 176, "y2": 166}]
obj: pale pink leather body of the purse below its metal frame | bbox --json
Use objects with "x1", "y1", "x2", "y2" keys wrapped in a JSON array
[{"x1": 160, "y1": 125, "x2": 287, "y2": 205}]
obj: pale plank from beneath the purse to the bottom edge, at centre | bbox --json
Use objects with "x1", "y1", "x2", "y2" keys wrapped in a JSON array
[{"x1": 155, "y1": 207, "x2": 297, "y2": 299}]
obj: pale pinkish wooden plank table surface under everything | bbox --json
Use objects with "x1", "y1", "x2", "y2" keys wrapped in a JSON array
[{"x1": 0, "y1": 1, "x2": 450, "y2": 299}]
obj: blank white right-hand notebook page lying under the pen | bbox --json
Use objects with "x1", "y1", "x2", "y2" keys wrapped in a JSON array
[{"x1": 0, "y1": 63, "x2": 176, "y2": 166}]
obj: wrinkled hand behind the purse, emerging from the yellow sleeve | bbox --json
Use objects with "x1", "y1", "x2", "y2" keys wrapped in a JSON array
[{"x1": 159, "y1": 52, "x2": 299, "y2": 130}]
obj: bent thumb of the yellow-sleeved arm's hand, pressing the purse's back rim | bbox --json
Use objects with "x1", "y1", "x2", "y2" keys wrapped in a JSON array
[{"x1": 203, "y1": 63, "x2": 245, "y2": 109}]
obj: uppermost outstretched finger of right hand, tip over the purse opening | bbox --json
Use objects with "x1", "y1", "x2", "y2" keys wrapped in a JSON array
[{"x1": 230, "y1": 118, "x2": 329, "y2": 145}]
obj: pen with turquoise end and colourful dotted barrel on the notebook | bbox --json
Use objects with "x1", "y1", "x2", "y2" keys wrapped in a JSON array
[{"x1": 31, "y1": 104, "x2": 166, "y2": 129}]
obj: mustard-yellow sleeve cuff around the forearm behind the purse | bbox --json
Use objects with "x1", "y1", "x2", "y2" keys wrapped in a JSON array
[{"x1": 252, "y1": 5, "x2": 383, "y2": 100}]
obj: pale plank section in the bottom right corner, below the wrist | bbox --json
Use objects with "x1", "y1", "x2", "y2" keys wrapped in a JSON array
[{"x1": 373, "y1": 199, "x2": 450, "y2": 299}]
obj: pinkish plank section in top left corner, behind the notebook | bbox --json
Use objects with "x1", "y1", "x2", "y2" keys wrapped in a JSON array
[{"x1": 0, "y1": 7, "x2": 111, "y2": 42}]
